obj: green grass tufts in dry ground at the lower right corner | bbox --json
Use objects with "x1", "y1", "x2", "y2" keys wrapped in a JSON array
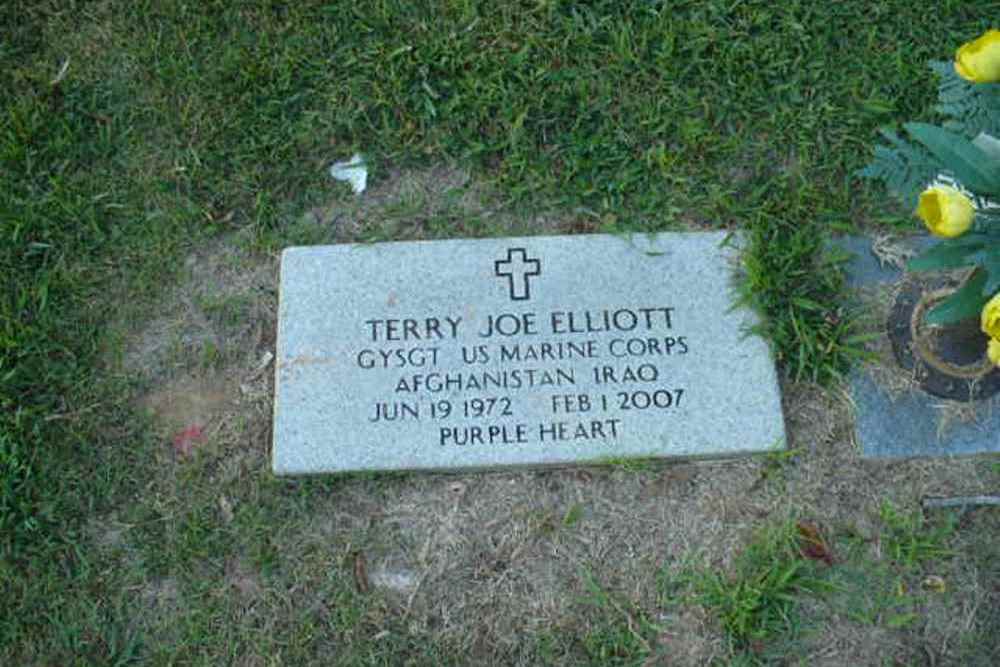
[{"x1": 676, "y1": 512, "x2": 964, "y2": 664}]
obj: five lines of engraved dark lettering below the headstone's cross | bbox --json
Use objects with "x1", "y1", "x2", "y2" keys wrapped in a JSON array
[{"x1": 356, "y1": 306, "x2": 689, "y2": 445}]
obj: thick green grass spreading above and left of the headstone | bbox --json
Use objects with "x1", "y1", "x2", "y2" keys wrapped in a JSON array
[{"x1": 0, "y1": 0, "x2": 990, "y2": 664}]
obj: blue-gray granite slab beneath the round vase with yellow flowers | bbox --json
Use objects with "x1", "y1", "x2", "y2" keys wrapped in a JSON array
[{"x1": 834, "y1": 235, "x2": 1000, "y2": 458}]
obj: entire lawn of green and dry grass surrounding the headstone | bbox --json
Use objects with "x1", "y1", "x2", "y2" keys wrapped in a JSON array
[{"x1": 0, "y1": 0, "x2": 1000, "y2": 665}]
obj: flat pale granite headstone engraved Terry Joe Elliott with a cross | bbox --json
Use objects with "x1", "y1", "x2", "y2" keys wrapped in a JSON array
[{"x1": 273, "y1": 233, "x2": 784, "y2": 475}]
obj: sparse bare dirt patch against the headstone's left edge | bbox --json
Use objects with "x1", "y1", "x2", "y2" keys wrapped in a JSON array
[{"x1": 121, "y1": 230, "x2": 277, "y2": 470}]
